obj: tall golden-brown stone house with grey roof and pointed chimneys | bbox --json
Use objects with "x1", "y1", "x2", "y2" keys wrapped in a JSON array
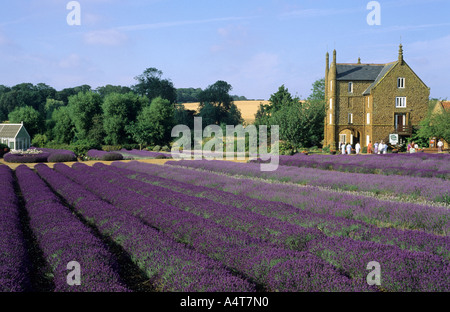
[{"x1": 324, "y1": 45, "x2": 430, "y2": 149}]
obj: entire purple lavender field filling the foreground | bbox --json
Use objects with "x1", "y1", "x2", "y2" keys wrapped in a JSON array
[{"x1": 0, "y1": 157, "x2": 450, "y2": 292}]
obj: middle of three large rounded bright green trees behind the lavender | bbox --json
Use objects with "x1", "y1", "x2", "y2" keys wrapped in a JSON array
[{"x1": 102, "y1": 92, "x2": 149, "y2": 145}]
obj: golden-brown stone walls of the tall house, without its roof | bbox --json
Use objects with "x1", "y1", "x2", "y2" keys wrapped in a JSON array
[{"x1": 324, "y1": 60, "x2": 430, "y2": 150}]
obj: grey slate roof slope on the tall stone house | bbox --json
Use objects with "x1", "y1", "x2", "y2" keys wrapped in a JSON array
[{"x1": 336, "y1": 64, "x2": 385, "y2": 81}]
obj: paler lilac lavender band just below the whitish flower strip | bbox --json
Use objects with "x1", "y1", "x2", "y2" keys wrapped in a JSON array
[{"x1": 117, "y1": 161, "x2": 450, "y2": 239}]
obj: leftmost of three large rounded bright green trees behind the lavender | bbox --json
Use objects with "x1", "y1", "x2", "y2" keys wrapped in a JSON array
[{"x1": 68, "y1": 92, "x2": 103, "y2": 140}]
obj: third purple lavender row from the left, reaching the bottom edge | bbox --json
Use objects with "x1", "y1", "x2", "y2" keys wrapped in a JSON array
[{"x1": 35, "y1": 165, "x2": 254, "y2": 292}]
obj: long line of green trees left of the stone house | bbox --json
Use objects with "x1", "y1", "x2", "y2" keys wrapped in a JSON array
[{"x1": 0, "y1": 68, "x2": 243, "y2": 152}]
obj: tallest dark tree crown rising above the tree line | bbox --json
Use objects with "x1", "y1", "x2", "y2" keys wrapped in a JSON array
[{"x1": 132, "y1": 67, "x2": 177, "y2": 103}]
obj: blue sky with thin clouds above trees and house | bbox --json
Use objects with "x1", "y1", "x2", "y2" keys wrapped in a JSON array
[{"x1": 0, "y1": 0, "x2": 450, "y2": 99}]
